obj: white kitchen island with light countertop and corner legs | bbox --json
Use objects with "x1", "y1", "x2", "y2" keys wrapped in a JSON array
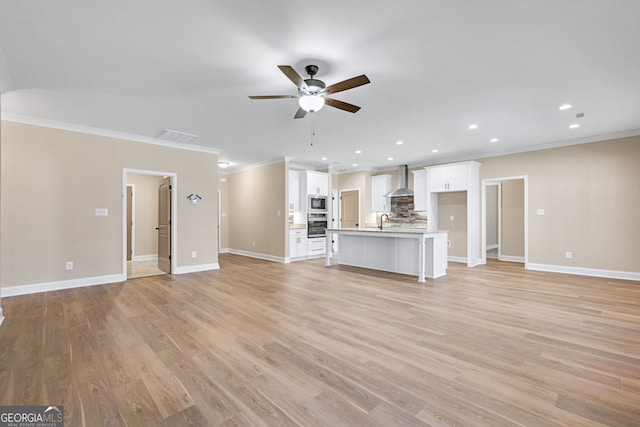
[{"x1": 325, "y1": 226, "x2": 447, "y2": 282}]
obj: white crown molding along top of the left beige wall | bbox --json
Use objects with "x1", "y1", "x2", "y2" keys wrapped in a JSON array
[{"x1": 2, "y1": 112, "x2": 222, "y2": 154}]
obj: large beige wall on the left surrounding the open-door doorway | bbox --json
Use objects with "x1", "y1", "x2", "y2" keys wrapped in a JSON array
[{"x1": 0, "y1": 121, "x2": 218, "y2": 287}]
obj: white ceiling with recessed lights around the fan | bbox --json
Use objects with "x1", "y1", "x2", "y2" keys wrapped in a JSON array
[{"x1": 0, "y1": 0, "x2": 640, "y2": 171}]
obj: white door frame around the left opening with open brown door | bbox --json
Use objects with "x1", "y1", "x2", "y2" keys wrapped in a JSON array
[{"x1": 122, "y1": 168, "x2": 178, "y2": 280}]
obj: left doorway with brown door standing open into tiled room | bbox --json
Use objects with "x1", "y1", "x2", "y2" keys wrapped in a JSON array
[{"x1": 123, "y1": 169, "x2": 177, "y2": 279}]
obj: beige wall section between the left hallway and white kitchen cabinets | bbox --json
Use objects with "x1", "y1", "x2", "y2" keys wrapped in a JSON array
[{"x1": 227, "y1": 161, "x2": 289, "y2": 258}]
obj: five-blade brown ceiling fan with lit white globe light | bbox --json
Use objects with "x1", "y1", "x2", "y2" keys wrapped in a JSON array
[{"x1": 249, "y1": 65, "x2": 370, "y2": 119}]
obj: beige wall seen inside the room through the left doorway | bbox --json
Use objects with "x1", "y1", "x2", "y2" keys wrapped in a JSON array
[{"x1": 127, "y1": 174, "x2": 162, "y2": 260}]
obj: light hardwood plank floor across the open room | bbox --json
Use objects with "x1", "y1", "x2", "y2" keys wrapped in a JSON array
[{"x1": 0, "y1": 254, "x2": 640, "y2": 426}]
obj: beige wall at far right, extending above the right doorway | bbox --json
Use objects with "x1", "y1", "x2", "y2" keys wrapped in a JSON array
[{"x1": 478, "y1": 136, "x2": 640, "y2": 272}]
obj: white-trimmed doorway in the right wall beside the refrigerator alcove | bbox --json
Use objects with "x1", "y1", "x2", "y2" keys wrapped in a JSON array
[{"x1": 481, "y1": 176, "x2": 529, "y2": 268}]
